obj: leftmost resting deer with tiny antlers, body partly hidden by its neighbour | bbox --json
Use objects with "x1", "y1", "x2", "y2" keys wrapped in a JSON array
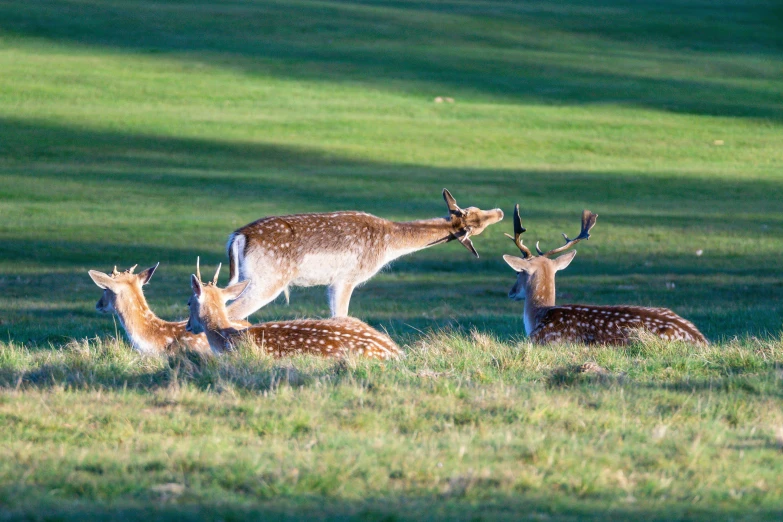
[{"x1": 89, "y1": 263, "x2": 210, "y2": 354}]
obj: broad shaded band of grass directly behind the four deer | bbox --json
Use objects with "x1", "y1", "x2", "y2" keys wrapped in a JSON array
[{"x1": 0, "y1": 118, "x2": 783, "y2": 343}]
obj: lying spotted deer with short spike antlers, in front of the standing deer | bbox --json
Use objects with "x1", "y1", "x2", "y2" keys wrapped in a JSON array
[{"x1": 186, "y1": 261, "x2": 402, "y2": 359}]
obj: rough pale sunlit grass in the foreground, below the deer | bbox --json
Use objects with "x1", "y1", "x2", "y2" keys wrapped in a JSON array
[{"x1": 0, "y1": 332, "x2": 783, "y2": 520}]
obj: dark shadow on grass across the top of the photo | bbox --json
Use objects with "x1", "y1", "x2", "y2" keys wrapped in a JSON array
[{"x1": 0, "y1": 0, "x2": 783, "y2": 121}]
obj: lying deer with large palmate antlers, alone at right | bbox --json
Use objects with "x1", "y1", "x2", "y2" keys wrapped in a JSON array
[{"x1": 503, "y1": 205, "x2": 707, "y2": 344}]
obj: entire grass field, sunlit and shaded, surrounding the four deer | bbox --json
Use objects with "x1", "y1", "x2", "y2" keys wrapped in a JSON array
[{"x1": 0, "y1": 0, "x2": 783, "y2": 520}]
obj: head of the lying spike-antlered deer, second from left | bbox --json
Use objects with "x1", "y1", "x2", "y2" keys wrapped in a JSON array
[{"x1": 185, "y1": 258, "x2": 250, "y2": 334}]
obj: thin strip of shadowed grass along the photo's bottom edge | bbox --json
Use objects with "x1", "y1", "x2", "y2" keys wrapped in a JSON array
[{"x1": 0, "y1": 486, "x2": 783, "y2": 522}]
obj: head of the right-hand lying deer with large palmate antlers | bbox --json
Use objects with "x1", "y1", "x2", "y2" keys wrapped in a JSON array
[{"x1": 503, "y1": 205, "x2": 598, "y2": 298}]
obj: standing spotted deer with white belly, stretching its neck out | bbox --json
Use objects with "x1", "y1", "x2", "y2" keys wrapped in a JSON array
[{"x1": 227, "y1": 189, "x2": 503, "y2": 319}]
